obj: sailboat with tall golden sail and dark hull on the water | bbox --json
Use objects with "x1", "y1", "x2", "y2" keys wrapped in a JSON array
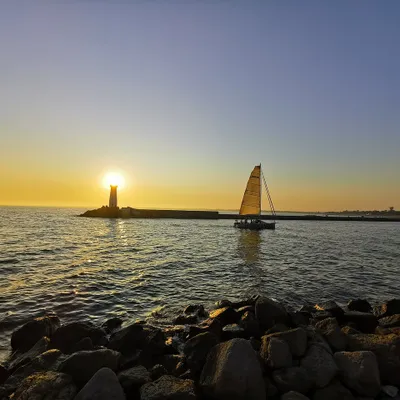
[{"x1": 234, "y1": 164, "x2": 276, "y2": 231}]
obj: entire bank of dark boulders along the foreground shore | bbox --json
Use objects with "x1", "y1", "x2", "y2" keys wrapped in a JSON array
[{"x1": 0, "y1": 296, "x2": 400, "y2": 400}]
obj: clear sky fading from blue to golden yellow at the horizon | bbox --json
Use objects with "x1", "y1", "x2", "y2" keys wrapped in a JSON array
[{"x1": 0, "y1": 0, "x2": 400, "y2": 211}]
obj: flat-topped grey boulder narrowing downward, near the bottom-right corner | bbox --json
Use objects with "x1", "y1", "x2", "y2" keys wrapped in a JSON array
[{"x1": 334, "y1": 351, "x2": 381, "y2": 397}]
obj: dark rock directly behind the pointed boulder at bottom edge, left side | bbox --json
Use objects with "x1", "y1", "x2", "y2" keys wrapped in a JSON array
[{"x1": 59, "y1": 349, "x2": 120, "y2": 385}]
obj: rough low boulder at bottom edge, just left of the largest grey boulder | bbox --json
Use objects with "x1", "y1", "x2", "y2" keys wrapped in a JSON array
[{"x1": 140, "y1": 375, "x2": 196, "y2": 400}]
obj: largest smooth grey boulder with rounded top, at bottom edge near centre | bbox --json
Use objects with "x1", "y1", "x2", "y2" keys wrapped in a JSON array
[{"x1": 199, "y1": 339, "x2": 266, "y2": 400}]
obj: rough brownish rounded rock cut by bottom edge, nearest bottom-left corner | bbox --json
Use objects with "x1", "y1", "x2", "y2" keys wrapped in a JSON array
[{"x1": 13, "y1": 371, "x2": 77, "y2": 400}]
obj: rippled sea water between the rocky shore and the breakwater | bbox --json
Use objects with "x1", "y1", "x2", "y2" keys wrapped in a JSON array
[{"x1": 0, "y1": 207, "x2": 400, "y2": 357}]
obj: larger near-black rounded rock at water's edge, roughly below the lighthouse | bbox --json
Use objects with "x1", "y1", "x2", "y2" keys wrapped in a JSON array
[{"x1": 108, "y1": 324, "x2": 146, "y2": 354}]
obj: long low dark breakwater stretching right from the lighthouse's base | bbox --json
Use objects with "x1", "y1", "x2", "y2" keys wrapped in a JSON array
[{"x1": 79, "y1": 207, "x2": 400, "y2": 222}]
